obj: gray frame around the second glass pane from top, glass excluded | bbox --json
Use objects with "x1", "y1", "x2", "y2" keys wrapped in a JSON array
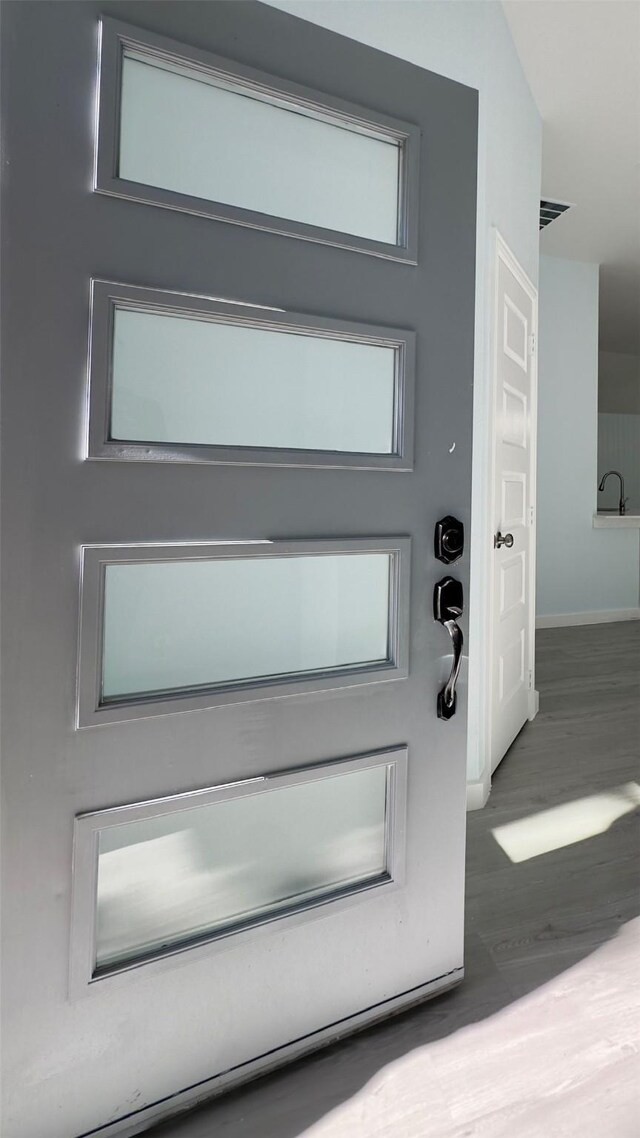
[{"x1": 85, "y1": 280, "x2": 416, "y2": 471}]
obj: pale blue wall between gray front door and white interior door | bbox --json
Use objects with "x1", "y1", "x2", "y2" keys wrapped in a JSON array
[{"x1": 263, "y1": 0, "x2": 542, "y2": 805}]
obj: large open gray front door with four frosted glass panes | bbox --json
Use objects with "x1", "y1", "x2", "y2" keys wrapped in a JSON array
[{"x1": 2, "y1": 0, "x2": 476, "y2": 1138}]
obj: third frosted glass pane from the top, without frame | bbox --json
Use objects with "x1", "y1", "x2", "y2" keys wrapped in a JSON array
[{"x1": 102, "y1": 553, "x2": 391, "y2": 701}]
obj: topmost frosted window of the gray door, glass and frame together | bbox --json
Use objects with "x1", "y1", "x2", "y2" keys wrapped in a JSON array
[{"x1": 93, "y1": 17, "x2": 420, "y2": 264}]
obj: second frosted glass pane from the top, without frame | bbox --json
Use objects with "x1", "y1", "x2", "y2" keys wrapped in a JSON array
[{"x1": 110, "y1": 308, "x2": 396, "y2": 454}]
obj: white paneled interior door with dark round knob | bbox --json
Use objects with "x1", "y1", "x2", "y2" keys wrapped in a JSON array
[{"x1": 490, "y1": 237, "x2": 538, "y2": 773}]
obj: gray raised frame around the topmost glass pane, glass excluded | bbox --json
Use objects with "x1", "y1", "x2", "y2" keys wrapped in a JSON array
[{"x1": 93, "y1": 17, "x2": 420, "y2": 264}]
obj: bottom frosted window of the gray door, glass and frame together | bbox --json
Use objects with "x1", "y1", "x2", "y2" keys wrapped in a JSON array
[{"x1": 69, "y1": 745, "x2": 408, "y2": 997}]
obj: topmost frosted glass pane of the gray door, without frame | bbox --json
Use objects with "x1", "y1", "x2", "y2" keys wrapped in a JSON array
[{"x1": 118, "y1": 52, "x2": 401, "y2": 245}]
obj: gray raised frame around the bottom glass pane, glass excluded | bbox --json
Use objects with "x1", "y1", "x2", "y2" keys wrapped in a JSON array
[{"x1": 69, "y1": 745, "x2": 408, "y2": 998}]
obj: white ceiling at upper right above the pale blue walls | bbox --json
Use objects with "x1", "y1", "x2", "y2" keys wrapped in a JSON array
[{"x1": 502, "y1": 0, "x2": 640, "y2": 355}]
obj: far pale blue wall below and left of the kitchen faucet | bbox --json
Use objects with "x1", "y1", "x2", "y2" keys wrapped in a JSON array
[{"x1": 538, "y1": 257, "x2": 639, "y2": 617}]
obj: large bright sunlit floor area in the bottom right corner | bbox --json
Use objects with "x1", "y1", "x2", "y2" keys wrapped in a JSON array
[{"x1": 296, "y1": 920, "x2": 640, "y2": 1138}]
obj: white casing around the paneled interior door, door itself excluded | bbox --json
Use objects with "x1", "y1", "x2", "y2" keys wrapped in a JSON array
[{"x1": 482, "y1": 228, "x2": 540, "y2": 806}]
